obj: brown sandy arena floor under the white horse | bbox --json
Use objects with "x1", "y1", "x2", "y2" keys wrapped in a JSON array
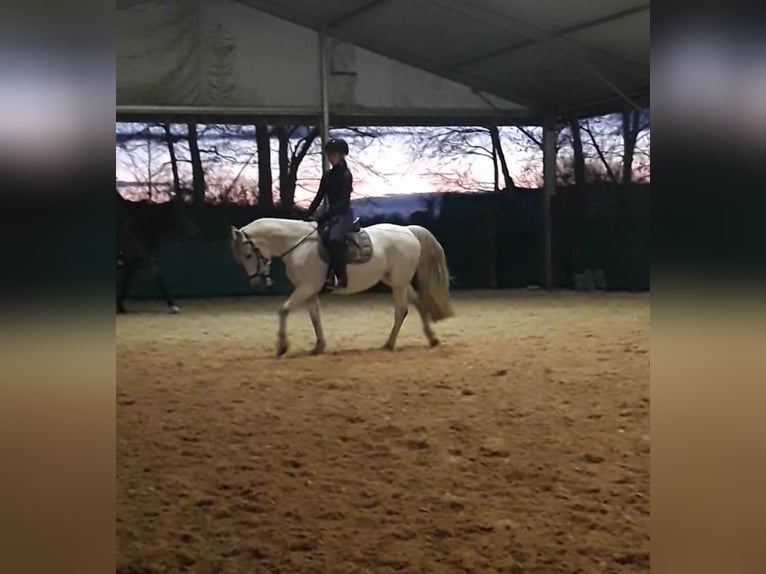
[{"x1": 117, "y1": 292, "x2": 649, "y2": 574}]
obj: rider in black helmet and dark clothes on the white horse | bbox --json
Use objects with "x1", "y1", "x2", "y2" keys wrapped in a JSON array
[{"x1": 306, "y1": 138, "x2": 354, "y2": 289}]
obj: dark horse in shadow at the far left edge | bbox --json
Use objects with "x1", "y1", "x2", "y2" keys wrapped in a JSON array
[{"x1": 117, "y1": 192, "x2": 198, "y2": 313}]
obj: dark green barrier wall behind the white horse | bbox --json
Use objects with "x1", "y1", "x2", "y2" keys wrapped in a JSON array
[{"x1": 124, "y1": 185, "x2": 650, "y2": 298}]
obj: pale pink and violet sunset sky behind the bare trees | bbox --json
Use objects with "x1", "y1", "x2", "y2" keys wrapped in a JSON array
[{"x1": 116, "y1": 119, "x2": 648, "y2": 205}]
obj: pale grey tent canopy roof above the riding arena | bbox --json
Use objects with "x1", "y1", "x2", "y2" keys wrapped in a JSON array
[{"x1": 117, "y1": 0, "x2": 649, "y2": 125}]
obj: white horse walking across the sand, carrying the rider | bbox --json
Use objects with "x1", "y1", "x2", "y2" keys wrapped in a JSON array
[{"x1": 231, "y1": 218, "x2": 453, "y2": 357}]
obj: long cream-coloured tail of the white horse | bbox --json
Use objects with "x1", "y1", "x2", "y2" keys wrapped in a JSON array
[{"x1": 408, "y1": 225, "x2": 455, "y2": 321}]
